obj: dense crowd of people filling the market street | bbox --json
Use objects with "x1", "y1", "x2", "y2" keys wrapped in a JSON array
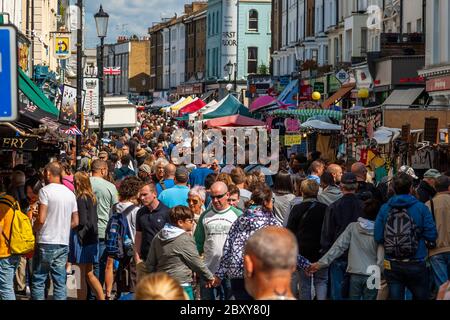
[{"x1": 0, "y1": 113, "x2": 450, "y2": 300}]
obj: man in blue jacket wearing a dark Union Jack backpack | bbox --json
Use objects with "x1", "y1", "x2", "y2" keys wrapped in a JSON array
[{"x1": 374, "y1": 173, "x2": 437, "y2": 300}]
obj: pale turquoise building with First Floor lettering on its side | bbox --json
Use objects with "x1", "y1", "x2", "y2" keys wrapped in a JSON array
[{"x1": 206, "y1": 0, "x2": 272, "y2": 81}]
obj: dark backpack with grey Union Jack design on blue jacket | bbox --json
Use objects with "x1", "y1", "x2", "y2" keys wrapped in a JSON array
[{"x1": 384, "y1": 207, "x2": 419, "y2": 259}]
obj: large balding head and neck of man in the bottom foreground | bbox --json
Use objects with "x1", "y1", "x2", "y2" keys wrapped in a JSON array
[{"x1": 244, "y1": 227, "x2": 298, "y2": 300}]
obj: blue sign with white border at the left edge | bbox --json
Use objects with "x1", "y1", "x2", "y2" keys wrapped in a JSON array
[{"x1": 0, "y1": 25, "x2": 19, "y2": 121}]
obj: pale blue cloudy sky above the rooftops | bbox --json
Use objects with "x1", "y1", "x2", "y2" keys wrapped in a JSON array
[{"x1": 84, "y1": 0, "x2": 186, "y2": 48}]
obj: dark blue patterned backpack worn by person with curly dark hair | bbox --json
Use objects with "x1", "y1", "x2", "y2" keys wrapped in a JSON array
[{"x1": 105, "y1": 204, "x2": 136, "y2": 260}]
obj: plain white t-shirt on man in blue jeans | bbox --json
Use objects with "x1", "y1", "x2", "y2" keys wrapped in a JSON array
[{"x1": 37, "y1": 183, "x2": 78, "y2": 246}]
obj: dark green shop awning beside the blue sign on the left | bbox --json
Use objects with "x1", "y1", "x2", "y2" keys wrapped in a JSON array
[{"x1": 18, "y1": 68, "x2": 59, "y2": 121}]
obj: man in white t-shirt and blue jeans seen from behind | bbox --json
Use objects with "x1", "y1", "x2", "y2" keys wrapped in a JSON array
[{"x1": 31, "y1": 162, "x2": 78, "y2": 300}]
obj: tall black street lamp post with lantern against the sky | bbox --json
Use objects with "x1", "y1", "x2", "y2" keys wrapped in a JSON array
[{"x1": 94, "y1": 5, "x2": 109, "y2": 148}]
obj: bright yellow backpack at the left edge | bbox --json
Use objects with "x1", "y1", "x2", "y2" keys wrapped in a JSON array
[{"x1": 0, "y1": 194, "x2": 35, "y2": 255}]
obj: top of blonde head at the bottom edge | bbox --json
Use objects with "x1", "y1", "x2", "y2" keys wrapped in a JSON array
[{"x1": 134, "y1": 272, "x2": 189, "y2": 300}]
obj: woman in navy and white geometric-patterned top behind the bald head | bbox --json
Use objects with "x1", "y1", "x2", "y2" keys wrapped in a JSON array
[{"x1": 215, "y1": 184, "x2": 281, "y2": 300}]
